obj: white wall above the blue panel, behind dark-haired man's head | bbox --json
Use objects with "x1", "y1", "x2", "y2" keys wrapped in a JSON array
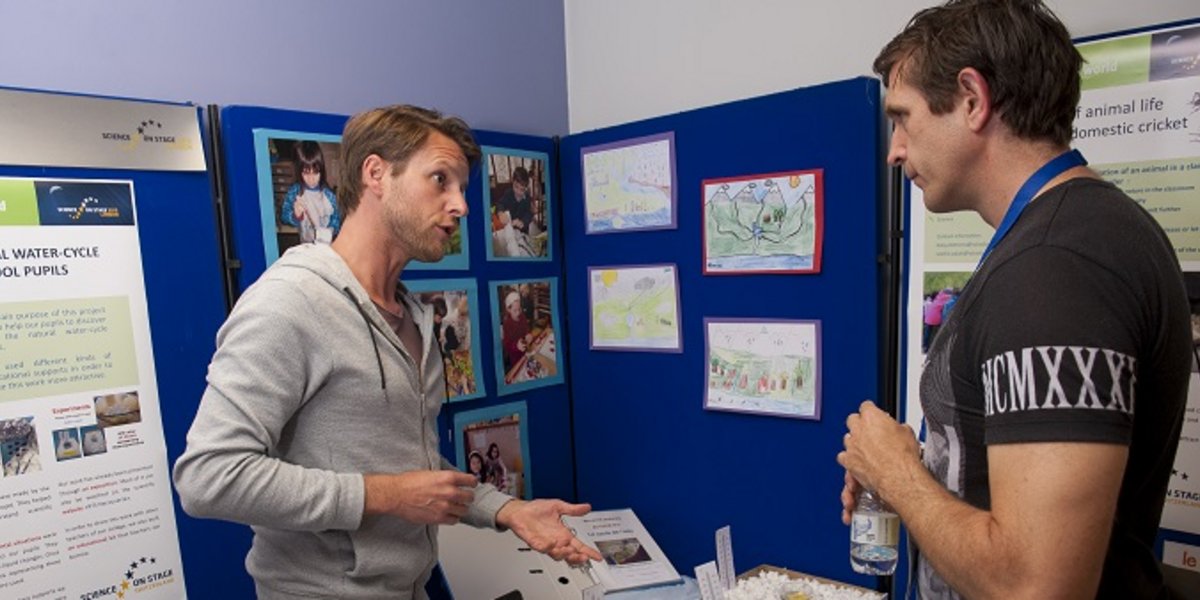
[{"x1": 564, "y1": 0, "x2": 1200, "y2": 133}]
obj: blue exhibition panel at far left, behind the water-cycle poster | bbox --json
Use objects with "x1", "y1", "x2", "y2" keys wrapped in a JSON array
[{"x1": 0, "y1": 105, "x2": 242, "y2": 598}]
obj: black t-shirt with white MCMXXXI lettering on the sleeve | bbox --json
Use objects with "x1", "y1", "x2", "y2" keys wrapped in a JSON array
[{"x1": 918, "y1": 179, "x2": 1190, "y2": 599}]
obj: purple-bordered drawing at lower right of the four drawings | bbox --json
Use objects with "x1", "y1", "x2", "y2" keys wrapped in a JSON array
[{"x1": 704, "y1": 318, "x2": 821, "y2": 420}]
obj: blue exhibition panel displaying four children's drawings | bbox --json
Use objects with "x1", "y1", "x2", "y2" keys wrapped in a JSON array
[{"x1": 559, "y1": 78, "x2": 886, "y2": 587}]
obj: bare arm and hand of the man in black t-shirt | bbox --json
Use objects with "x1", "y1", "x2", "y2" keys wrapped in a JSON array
[{"x1": 839, "y1": 406, "x2": 1128, "y2": 599}]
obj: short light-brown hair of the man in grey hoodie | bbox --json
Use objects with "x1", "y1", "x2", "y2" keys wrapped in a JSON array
[{"x1": 337, "y1": 104, "x2": 482, "y2": 215}]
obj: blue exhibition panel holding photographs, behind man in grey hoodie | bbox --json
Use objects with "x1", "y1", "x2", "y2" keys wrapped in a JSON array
[{"x1": 221, "y1": 107, "x2": 574, "y2": 499}]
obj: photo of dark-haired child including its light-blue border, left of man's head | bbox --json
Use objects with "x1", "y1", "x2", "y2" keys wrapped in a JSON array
[{"x1": 253, "y1": 128, "x2": 342, "y2": 266}]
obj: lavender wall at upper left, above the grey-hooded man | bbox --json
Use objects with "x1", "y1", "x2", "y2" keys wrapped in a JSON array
[{"x1": 0, "y1": 0, "x2": 566, "y2": 136}]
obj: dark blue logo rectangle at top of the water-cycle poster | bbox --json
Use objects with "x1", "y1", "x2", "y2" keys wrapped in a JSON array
[{"x1": 35, "y1": 180, "x2": 133, "y2": 226}]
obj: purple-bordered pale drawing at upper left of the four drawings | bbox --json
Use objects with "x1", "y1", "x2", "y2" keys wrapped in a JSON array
[{"x1": 580, "y1": 132, "x2": 678, "y2": 234}]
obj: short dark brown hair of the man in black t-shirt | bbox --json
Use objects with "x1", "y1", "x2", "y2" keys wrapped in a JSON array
[{"x1": 874, "y1": 0, "x2": 1084, "y2": 145}]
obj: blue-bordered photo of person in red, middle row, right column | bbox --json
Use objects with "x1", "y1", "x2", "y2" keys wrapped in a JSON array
[{"x1": 490, "y1": 277, "x2": 563, "y2": 395}]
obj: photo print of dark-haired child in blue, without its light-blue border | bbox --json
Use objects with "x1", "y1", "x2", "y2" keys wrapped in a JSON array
[{"x1": 266, "y1": 138, "x2": 342, "y2": 254}]
